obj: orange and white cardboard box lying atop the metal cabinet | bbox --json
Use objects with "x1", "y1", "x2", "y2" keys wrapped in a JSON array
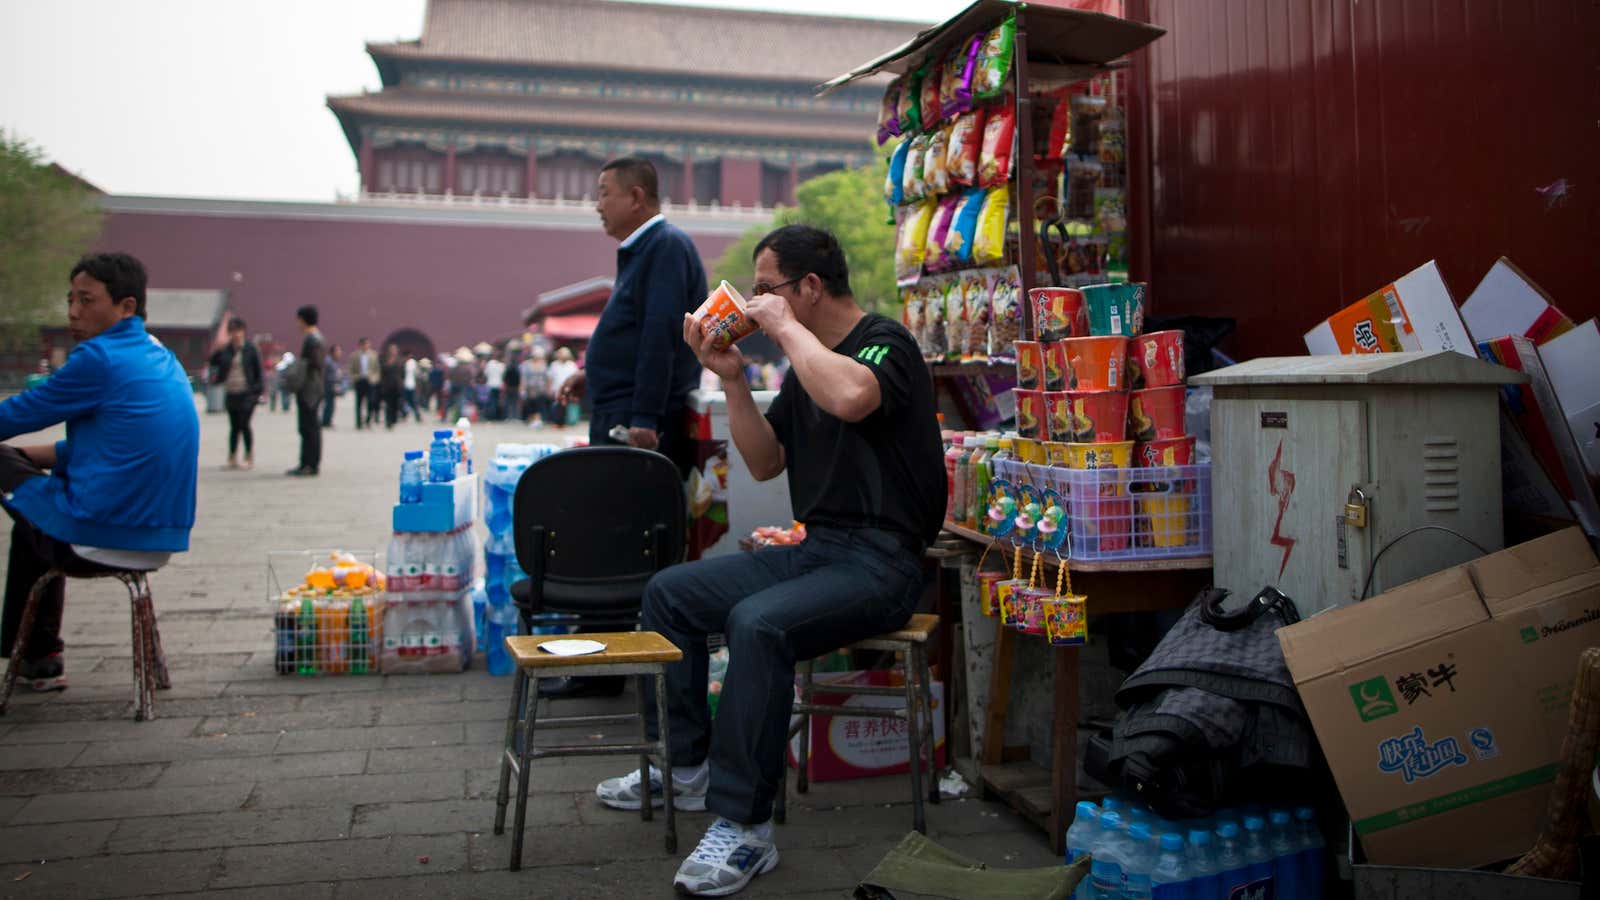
[{"x1": 1306, "y1": 261, "x2": 1474, "y2": 356}]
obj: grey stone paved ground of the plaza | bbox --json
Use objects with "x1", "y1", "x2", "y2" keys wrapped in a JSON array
[{"x1": 0, "y1": 404, "x2": 1056, "y2": 898}]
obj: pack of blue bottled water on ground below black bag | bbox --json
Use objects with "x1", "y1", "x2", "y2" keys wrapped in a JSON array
[{"x1": 1067, "y1": 796, "x2": 1326, "y2": 900}]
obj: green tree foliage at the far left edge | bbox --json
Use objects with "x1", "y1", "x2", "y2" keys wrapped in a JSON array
[{"x1": 0, "y1": 130, "x2": 101, "y2": 348}]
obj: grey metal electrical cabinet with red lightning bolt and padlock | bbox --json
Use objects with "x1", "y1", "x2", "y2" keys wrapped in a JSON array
[{"x1": 1189, "y1": 352, "x2": 1525, "y2": 617}]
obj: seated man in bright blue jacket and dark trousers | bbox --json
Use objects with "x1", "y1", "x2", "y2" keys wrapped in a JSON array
[{"x1": 0, "y1": 253, "x2": 200, "y2": 690}]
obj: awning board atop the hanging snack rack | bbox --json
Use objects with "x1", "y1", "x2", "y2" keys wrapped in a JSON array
[{"x1": 818, "y1": 0, "x2": 1166, "y2": 94}]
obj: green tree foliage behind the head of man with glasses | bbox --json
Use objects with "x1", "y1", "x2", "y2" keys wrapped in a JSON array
[{"x1": 712, "y1": 160, "x2": 896, "y2": 312}]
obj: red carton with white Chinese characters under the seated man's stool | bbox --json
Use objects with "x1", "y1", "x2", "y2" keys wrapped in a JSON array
[{"x1": 789, "y1": 669, "x2": 944, "y2": 781}]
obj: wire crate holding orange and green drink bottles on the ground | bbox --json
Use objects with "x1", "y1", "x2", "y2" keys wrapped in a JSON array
[{"x1": 267, "y1": 549, "x2": 387, "y2": 676}]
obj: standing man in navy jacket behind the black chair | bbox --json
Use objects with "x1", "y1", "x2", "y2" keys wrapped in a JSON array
[{"x1": 560, "y1": 157, "x2": 706, "y2": 476}]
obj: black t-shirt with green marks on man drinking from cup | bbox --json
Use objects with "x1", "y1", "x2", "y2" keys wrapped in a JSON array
[{"x1": 766, "y1": 312, "x2": 946, "y2": 544}]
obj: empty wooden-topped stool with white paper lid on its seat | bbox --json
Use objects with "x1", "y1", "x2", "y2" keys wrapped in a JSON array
[{"x1": 494, "y1": 631, "x2": 683, "y2": 871}]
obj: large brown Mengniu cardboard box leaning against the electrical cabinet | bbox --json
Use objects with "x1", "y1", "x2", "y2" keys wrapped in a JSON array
[{"x1": 1278, "y1": 528, "x2": 1600, "y2": 868}]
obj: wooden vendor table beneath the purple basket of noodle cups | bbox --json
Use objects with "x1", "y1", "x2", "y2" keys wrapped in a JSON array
[{"x1": 944, "y1": 522, "x2": 1211, "y2": 852}]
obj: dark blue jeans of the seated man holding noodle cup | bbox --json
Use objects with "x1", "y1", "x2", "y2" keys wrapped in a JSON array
[{"x1": 640, "y1": 527, "x2": 922, "y2": 825}]
